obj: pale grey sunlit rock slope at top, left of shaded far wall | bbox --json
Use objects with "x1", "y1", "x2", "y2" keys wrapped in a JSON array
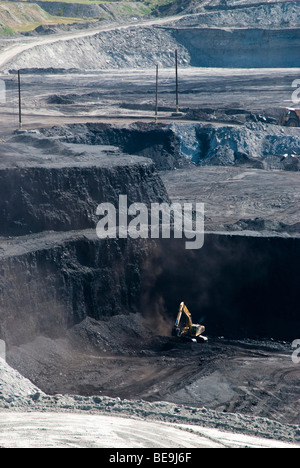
[{"x1": 6, "y1": 27, "x2": 190, "y2": 71}]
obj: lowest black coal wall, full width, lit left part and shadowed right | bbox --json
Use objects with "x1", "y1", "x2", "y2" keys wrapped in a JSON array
[{"x1": 0, "y1": 232, "x2": 300, "y2": 347}]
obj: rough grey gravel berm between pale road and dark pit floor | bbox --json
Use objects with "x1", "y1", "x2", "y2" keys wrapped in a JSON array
[{"x1": 0, "y1": 359, "x2": 300, "y2": 446}]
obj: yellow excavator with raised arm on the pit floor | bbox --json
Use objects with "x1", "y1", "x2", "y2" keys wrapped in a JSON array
[{"x1": 172, "y1": 302, "x2": 208, "y2": 343}]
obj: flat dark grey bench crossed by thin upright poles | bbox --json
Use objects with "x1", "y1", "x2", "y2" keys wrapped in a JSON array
[{"x1": 0, "y1": 68, "x2": 299, "y2": 136}]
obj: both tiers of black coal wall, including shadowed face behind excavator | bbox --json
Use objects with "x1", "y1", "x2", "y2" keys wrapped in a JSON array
[{"x1": 0, "y1": 130, "x2": 300, "y2": 346}]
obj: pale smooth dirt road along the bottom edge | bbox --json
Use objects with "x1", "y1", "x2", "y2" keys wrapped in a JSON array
[{"x1": 0, "y1": 412, "x2": 299, "y2": 448}]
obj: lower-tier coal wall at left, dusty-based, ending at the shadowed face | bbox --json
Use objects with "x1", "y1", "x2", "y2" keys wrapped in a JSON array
[{"x1": 0, "y1": 231, "x2": 148, "y2": 347}]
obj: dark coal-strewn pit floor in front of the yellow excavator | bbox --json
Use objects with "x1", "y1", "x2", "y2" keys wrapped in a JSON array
[{"x1": 7, "y1": 330, "x2": 300, "y2": 424}]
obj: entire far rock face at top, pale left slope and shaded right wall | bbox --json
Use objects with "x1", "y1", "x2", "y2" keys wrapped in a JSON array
[{"x1": 6, "y1": 10, "x2": 300, "y2": 70}]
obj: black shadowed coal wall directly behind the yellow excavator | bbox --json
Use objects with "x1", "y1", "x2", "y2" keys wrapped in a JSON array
[{"x1": 141, "y1": 235, "x2": 299, "y2": 340}]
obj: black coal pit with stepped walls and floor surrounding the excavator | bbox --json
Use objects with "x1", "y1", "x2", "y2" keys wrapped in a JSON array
[{"x1": 0, "y1": 123, "x2": 300, "y2": 424}]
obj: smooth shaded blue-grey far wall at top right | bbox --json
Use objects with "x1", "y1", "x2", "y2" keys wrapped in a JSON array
[{"x1": 173, "y1": 27, "x2": 300, "y2": 68}]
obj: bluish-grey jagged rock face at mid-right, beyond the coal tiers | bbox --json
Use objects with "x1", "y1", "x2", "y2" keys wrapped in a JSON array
[{"x1": 171, "y1": 123, "x2": 300, "y2": 171}]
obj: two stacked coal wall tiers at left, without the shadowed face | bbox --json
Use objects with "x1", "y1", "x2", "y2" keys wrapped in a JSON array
[{"x1": 0, "y1": 134, "x2": 169, "y2": 346}]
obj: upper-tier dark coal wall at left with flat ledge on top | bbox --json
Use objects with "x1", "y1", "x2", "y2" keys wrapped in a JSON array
[{"x1": 0, "y1": 153, "x2": 168, "y2": 236}]
